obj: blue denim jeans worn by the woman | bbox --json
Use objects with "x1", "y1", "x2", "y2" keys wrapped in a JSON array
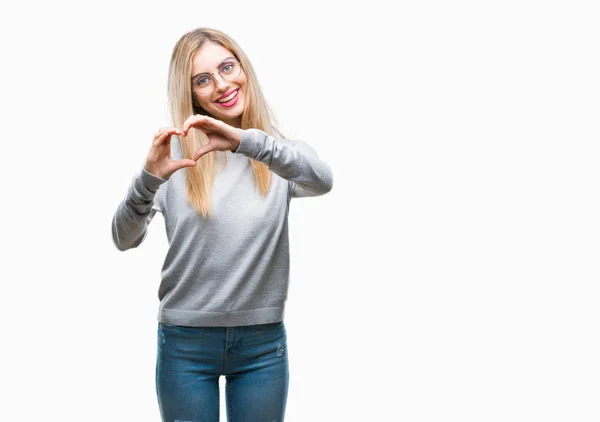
[{"x1": 156, "y1": 321, "x2": 289, "y2": 422}]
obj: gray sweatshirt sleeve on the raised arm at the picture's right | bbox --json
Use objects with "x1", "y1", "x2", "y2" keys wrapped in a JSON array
[{"x1": 234, "y1": 129, "x2": 333, "y2": 197}]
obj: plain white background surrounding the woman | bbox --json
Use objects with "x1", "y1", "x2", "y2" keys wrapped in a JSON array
[{"x1": 0, "y1": 0, "x2": 600, "y2": 422}]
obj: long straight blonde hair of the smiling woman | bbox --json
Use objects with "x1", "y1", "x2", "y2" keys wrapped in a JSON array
[{"x1": 168, "y1": 28, "x2": 281, "y2": 218}]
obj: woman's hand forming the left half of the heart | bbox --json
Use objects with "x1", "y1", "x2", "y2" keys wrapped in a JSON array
[{"x1": 144, "y1": 127, "x2": 196, "y2": 179}]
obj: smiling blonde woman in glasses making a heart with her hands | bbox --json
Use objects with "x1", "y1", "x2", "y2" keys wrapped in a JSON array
[{"x1": 112, "y1": 28, "x2": 333, "y2": 422}]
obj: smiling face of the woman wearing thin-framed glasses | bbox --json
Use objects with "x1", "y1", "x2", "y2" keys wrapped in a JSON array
[{"x1": 192, "y1": 41, "x2": 248, "y2": 127}]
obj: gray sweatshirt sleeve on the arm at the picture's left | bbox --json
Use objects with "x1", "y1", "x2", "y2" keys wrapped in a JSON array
[{"x1": 112, "y1": 168, "x2": 167, "y2": 251}]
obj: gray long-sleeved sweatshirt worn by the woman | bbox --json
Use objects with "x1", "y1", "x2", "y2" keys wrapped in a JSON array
[{"x1": 112, "y1": 129, "x2": 333, "y2": 327}]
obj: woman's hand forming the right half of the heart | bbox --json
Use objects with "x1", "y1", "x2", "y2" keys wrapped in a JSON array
[{"x1": 181, "y1": 114, "x2": 244, "y2": 161}]
